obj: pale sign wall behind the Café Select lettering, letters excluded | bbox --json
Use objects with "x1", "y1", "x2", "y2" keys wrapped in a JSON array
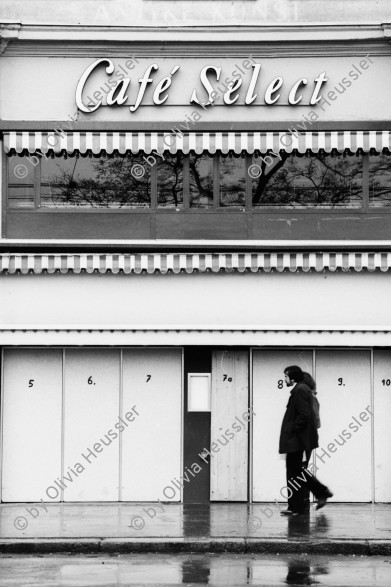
[{"x1": 0, "y1": 50, "x2": 391, "y2": 124}]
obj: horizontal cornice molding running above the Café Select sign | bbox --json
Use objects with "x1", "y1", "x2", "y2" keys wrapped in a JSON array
[{"x1": 0, "y1": 22, "x2": 391, "y2": 58}]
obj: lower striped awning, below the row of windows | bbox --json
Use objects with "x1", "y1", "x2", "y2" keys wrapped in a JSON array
[{"x1": 0, "y1": 252, "x2": 391, "y2": 274}]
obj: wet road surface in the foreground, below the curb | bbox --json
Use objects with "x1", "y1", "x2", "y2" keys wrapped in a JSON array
[{"x1": 0, "y1": 554, "x2": 391, "y2": 587}]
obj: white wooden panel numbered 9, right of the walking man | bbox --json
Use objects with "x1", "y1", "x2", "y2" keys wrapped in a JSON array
[{"x1": 315, "y1": 350, "x2": 372, "y2": 502}]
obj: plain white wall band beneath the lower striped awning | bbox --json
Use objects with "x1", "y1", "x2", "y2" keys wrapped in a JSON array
[{"x1": 0, "y1": 272, "x2": 391, "y2": 328}]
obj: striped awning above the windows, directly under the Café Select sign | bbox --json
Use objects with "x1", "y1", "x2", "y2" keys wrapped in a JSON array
[{"x1": 4, "y1": 129, "x2": 391, "y2": 155}]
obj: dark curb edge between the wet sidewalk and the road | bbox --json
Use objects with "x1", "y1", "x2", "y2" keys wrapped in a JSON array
[{"x1": 0, "y1": 538, "x2": 391, "y2": 556}]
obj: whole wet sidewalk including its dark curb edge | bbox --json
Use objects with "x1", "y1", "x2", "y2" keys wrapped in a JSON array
[{"x1": 0, "y1": 503, "x2": 391, "y2": 555}]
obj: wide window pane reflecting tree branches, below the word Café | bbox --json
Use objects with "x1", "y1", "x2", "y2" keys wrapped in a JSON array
[{"x1": 44, "y1": 155, "x2": 150, "y2": 208}]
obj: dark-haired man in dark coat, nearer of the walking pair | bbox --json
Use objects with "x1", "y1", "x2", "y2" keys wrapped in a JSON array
[{"x1": 279, "y1": 365, "x2": 332, "y2": 515}]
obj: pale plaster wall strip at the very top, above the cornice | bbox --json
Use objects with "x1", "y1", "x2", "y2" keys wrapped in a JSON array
[{"x1": 0, "y1": 0, "x2": 391, "y2": 26}]
